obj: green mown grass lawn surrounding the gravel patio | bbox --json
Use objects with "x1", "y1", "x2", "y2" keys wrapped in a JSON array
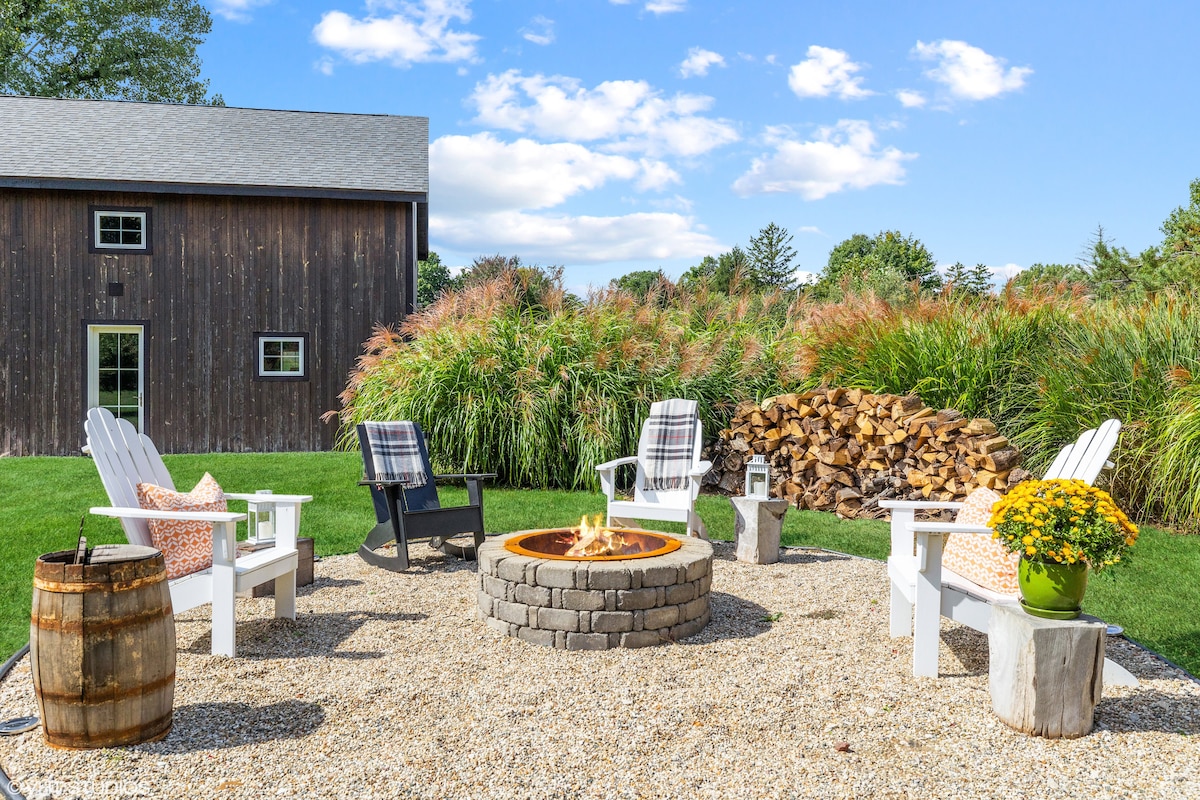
[{"x1": 0, "y1": 453, "x2": 1200, "y2": 674}]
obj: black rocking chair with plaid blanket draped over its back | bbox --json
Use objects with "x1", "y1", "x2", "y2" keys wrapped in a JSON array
[{"x1": 358, "y1": 422, "x2": 496, "y2": 572}]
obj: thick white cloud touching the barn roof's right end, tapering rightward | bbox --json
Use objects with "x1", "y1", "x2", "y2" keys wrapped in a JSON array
[{"x1": 430, "y1": 133, "x2": 679, "y2": 216}]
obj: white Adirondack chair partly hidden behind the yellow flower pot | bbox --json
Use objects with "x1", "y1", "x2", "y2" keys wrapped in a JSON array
[{"x1": 880, "y1": 420, "x2": 1138, "y2": 686}]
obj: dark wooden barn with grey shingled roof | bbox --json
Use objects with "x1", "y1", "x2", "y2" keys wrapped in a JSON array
[{"x1": 0, "y1": 97, "x2": 428, "y2": 456}]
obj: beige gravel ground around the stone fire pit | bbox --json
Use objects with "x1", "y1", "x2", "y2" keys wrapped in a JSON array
[{"x1": 0, "y1": 543, "x2": 1200, "y2": 800}]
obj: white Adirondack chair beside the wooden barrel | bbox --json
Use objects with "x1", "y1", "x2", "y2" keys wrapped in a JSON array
[{"x1": 84, "y1": 408, "x2": 312, "y2": 656}]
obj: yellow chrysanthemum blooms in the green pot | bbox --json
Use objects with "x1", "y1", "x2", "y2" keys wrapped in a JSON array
[{"x1": 988, "y1": 479, "x2": 1138, "y2": 572}]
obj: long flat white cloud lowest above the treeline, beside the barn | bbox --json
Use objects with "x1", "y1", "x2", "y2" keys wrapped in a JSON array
[{"x1": 430, "y1": 211, "x2": 725, "y2": 264}]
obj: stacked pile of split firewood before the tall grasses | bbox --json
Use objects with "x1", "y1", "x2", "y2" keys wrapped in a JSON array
[{"x1": 704, "y1": 387, "x2": 1030, "y2": 517}]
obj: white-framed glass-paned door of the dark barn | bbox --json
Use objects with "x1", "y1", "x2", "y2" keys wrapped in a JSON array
[{"x1": 88, "y1": 325, "x2": 145, "y2": 433}]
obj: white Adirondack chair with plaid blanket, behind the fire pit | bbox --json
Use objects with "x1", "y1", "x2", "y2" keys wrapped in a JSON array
[{"x1": 596, "y1": 407, "x2": 713, "y2": 539}]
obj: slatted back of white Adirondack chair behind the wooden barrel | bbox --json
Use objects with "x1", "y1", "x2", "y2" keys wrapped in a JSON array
[{"x1": 84, "y1": 408, "x2": 175, "y2": 547}]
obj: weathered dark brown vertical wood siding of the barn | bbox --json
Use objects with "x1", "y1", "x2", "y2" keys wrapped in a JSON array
[{"x1": 0, "y1": 183, "x2": 413, "y2": 455}]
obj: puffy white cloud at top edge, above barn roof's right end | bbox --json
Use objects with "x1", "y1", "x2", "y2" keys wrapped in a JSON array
[{"x1": 312, "y1": 0, "x2": 479, "y2": 66}]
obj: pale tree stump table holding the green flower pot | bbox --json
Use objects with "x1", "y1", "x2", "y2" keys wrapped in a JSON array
[{"x1": 988, "y1": 603, "x2": 1105, "y2": 739}]
